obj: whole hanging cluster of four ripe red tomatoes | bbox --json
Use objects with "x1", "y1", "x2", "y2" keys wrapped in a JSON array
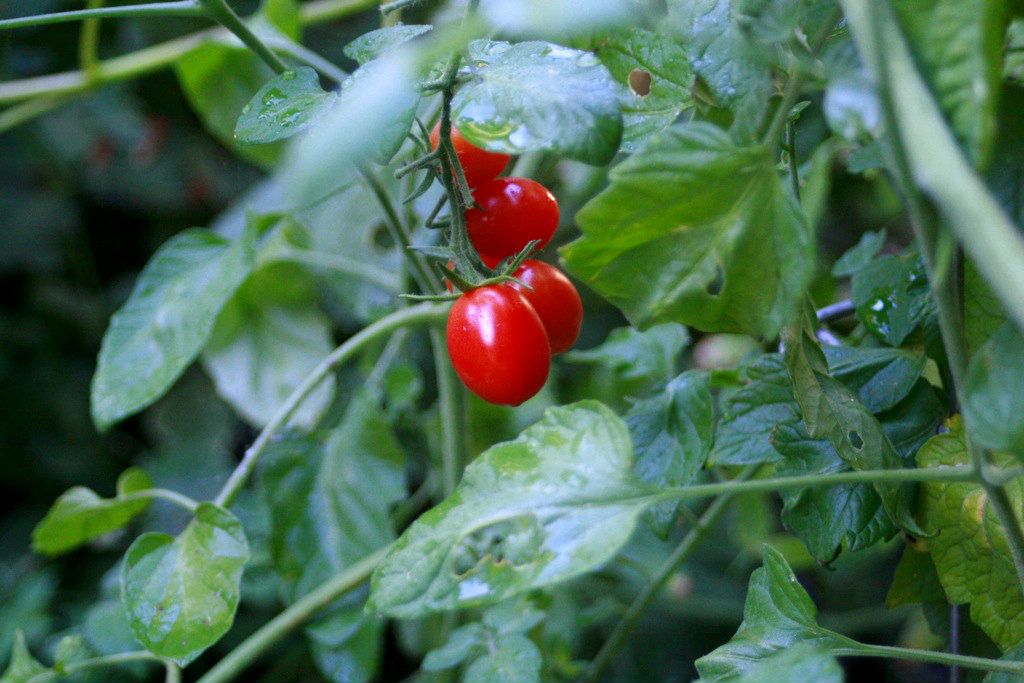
[{"x1": 430, "y1": 127, "x2": 583, "y2": 405}]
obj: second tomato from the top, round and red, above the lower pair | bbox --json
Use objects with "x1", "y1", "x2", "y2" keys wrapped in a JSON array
[{"x1": 466, "y1": 178, "x2": 558, "y2": 260}]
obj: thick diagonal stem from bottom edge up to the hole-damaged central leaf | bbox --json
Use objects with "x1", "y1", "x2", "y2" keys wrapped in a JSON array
[{"x1": 199, "y1": 545, "x2": 391, "y2": 683}]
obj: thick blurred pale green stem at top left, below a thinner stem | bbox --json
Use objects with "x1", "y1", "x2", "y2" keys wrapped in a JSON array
[{"x1": 0, "y1": 0, "x2": 377, "y2": 104}]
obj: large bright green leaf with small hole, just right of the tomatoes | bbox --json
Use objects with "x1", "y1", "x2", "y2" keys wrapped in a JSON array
[{"x1": 562, "y1": 123, "x2": 814, "y2": 337}]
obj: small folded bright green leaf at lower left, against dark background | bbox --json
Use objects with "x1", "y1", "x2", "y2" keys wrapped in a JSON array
[{"x1": 32, "y1": 468, "x2": 153, "y2": 556}]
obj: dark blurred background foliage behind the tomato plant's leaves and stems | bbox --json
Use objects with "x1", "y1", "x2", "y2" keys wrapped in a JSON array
[{"x1": 0, "y1": 0, "x2": 966, "y2": 683}]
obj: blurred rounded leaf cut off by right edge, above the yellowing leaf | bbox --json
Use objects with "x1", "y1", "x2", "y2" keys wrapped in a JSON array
[{"x1": 964, "y1": 323, "x2": 1024, "y2": 460}]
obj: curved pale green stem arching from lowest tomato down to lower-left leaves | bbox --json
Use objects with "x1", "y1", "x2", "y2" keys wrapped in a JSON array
[{"x1": 214, "y1": 303, "x2": 449, "y2": 507}]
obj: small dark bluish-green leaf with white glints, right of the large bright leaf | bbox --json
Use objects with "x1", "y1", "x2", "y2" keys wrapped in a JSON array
[{"x1": 851, "y1": 254, "x2": 931, "y2": 346}]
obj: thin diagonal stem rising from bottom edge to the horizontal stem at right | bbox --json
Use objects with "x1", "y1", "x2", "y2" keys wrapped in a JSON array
[{"x1": 581, "y1": 465, "x2": 759, "y2": 683}]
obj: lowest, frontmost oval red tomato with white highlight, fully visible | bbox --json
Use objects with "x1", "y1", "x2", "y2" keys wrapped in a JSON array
[{"x1": 447, "y1": 285, "x2": 551, "y2": 405}]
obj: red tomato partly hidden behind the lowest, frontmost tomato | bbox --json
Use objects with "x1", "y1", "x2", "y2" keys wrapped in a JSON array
[{"x1": 508, "y1": 259, "x2": 583, "y2": 353}]
